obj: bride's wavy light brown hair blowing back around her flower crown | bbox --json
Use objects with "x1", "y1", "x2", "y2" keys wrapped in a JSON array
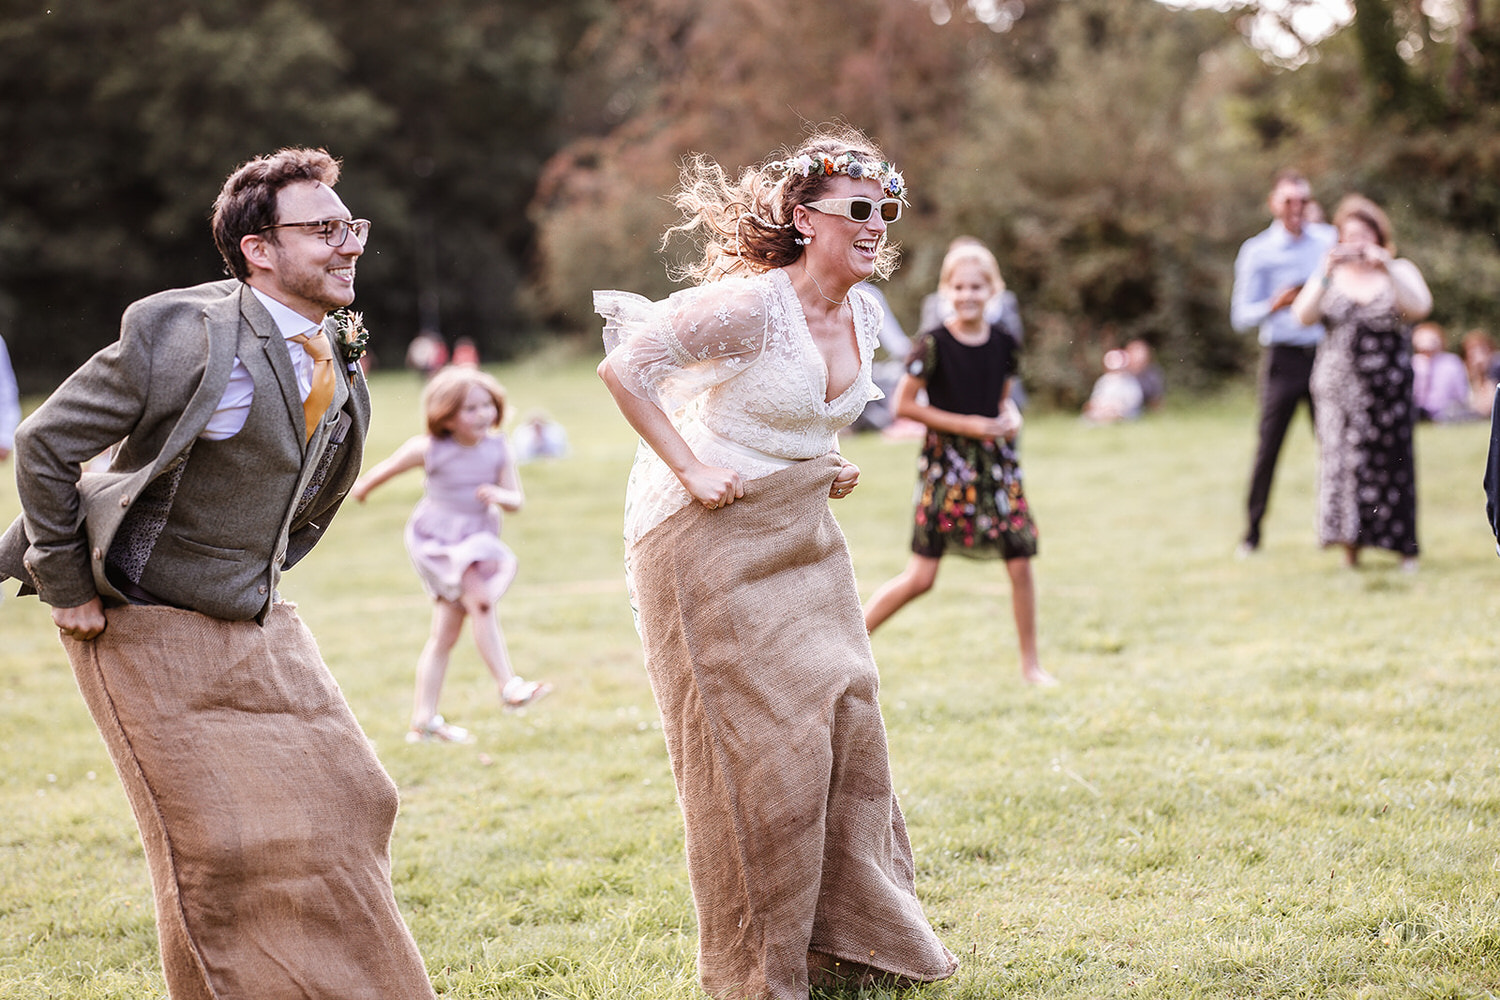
[{"x1": 662, "y1": 126, "x2": 900, "y2": 285}]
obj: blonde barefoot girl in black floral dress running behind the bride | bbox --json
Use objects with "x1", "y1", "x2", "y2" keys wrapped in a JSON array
[{"x1": 864, "y1": 241, "x2": 1058, "y2": 685}]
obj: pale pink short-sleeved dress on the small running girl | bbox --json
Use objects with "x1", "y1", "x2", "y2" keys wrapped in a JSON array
[{"x1": 407, "y1": 433, "x2": 516, "y2": 601}]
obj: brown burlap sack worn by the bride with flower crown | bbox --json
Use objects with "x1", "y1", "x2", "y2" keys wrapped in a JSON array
[{"x1": 632, "y1": 457, "x2": 959, "y2": 1000}]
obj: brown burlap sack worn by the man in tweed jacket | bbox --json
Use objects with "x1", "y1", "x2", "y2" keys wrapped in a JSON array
[{"x1": 63, "y1": 604, "x2": 434, "y2": 1000}]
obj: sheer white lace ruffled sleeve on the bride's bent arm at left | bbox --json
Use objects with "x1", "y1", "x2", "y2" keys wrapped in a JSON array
[{"x1": 594, "y1": 279, "x2": 770, "y2": 415}]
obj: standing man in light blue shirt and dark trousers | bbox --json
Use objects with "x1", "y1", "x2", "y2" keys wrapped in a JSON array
[{"x1": 1230, "y1": 171, "x2": 1338, "y2": 555}]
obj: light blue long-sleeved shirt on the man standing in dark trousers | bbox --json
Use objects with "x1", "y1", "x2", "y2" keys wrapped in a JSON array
[{"x1": 1229, "y1": 220, "x2": 1338, "y2": 346}]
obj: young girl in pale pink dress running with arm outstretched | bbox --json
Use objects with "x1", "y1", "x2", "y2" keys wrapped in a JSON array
[{"x1": 350, "y1": 367, "x2": 552, "y2": 742}]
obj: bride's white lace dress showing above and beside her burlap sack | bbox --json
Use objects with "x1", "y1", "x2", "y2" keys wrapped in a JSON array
[{"x1": 594, "y1": 270, "x2": 882, "y2": 544}]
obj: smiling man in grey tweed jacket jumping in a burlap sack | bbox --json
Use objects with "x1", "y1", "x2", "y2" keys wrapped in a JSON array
[{"x1": 0, "y1": 148, "x2": 434, "y2": 1000}]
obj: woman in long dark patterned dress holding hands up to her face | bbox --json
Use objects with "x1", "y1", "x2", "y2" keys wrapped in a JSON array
[{"x1": 1292, "y1": 195, "x2": 1433, "y2": 571}]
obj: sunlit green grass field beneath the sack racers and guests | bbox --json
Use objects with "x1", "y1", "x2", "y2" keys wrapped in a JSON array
[{"x1": 0, "y1": 340, "x2": 1500, "y2": 1000}]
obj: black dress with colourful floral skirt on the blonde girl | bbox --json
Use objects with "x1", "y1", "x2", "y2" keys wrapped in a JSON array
[{"x1": 906, "y1": 325, "x2": 1037, "y2": 559}]
